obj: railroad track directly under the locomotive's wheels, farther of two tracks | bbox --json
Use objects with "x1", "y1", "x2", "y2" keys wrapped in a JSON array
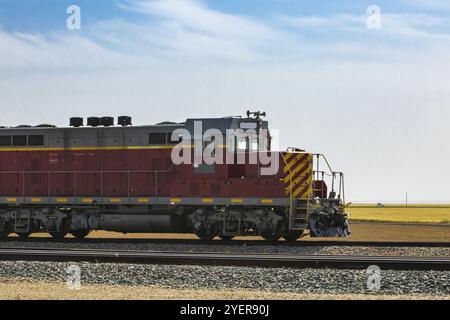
[{"x1": 1, "y1": 237, "x2": 450, "y2": 248}]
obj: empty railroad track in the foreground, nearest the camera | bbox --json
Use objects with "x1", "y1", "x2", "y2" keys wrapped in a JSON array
[{"x1": 0, "y1": 248, "x2": 450, "y2": 271}]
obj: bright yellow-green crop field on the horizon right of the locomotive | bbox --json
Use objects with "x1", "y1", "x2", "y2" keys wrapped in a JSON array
[{"x1": 346, "y1": 204, "x2": 450, "y2": 224}]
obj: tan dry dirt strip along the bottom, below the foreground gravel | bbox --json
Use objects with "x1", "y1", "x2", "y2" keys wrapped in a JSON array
[{"x1": 0, "y1": 278, "x2": 450, "y2": 300}]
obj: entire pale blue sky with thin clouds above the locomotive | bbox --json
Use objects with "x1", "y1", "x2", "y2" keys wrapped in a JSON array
[{"x1": 0, "y1": 0, "x2": 450, "y2": 202}]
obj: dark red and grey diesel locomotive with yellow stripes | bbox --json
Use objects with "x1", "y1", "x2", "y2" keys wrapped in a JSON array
[{"x1": 0, "y1": 112, "x2": 350, "y2": 241}]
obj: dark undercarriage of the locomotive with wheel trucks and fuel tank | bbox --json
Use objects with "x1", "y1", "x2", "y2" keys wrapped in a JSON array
[{"x1": 0, "y1": 207, "x2": 298, "y2": 239}]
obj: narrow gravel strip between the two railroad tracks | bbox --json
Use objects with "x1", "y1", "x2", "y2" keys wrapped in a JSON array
[{"x1": 0, "y1": 241, "x2": 450, "y2": 257}]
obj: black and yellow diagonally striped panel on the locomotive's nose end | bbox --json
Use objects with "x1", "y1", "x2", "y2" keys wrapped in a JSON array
[{"x1": 282, "y1": 152, "x2": 313, "y2": 199}]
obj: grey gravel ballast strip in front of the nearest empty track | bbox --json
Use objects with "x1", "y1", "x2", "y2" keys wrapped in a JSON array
[{"x1": 0, "y1": 261, "x2": 450, "y2": 296}]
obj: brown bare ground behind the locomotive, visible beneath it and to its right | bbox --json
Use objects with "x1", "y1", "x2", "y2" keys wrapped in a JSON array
[{"x1": 10, "y1": 222, "x2": 450, "y2": 242}]
